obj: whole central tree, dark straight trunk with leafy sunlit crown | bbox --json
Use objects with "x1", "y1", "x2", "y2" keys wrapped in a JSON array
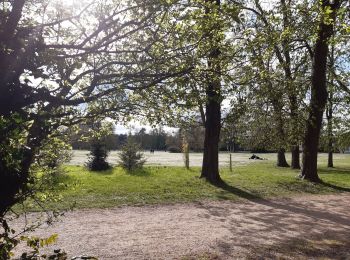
[{"x1": 133, "y1": 0, "x2": 239, "y2": 183}]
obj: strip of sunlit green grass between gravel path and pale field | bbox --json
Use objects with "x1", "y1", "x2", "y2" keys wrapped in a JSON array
[{"x1": 27, "y1": 154, "x2": 350, "y2": 210}]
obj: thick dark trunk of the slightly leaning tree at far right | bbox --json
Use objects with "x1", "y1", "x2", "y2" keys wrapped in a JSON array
[{"x1": 301, "y1": 0, "x2": 340, "y2": 182}]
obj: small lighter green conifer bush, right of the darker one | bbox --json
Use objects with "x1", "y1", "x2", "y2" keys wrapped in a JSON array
[{"x1": 119, "y1": 138, "x2": 146, "y2": 171}]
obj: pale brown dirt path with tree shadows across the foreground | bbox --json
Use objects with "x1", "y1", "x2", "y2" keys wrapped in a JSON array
[{"x1": 13, "y1": 194, "x2": 350, "y2": 259}]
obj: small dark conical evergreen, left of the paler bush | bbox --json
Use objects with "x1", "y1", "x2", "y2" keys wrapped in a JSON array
[{"x1": 86, "y1": 141, "x2": 111, "y2": 171}]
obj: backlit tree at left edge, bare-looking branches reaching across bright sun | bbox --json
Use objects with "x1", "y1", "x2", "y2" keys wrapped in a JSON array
[{"x1": 0, "y1": 0, "x2": 183, "y2": 233}]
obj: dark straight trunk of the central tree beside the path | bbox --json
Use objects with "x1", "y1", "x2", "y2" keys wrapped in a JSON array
[{"x1": 201, "y1": 0, "x2": 222, "y2": 184}]
